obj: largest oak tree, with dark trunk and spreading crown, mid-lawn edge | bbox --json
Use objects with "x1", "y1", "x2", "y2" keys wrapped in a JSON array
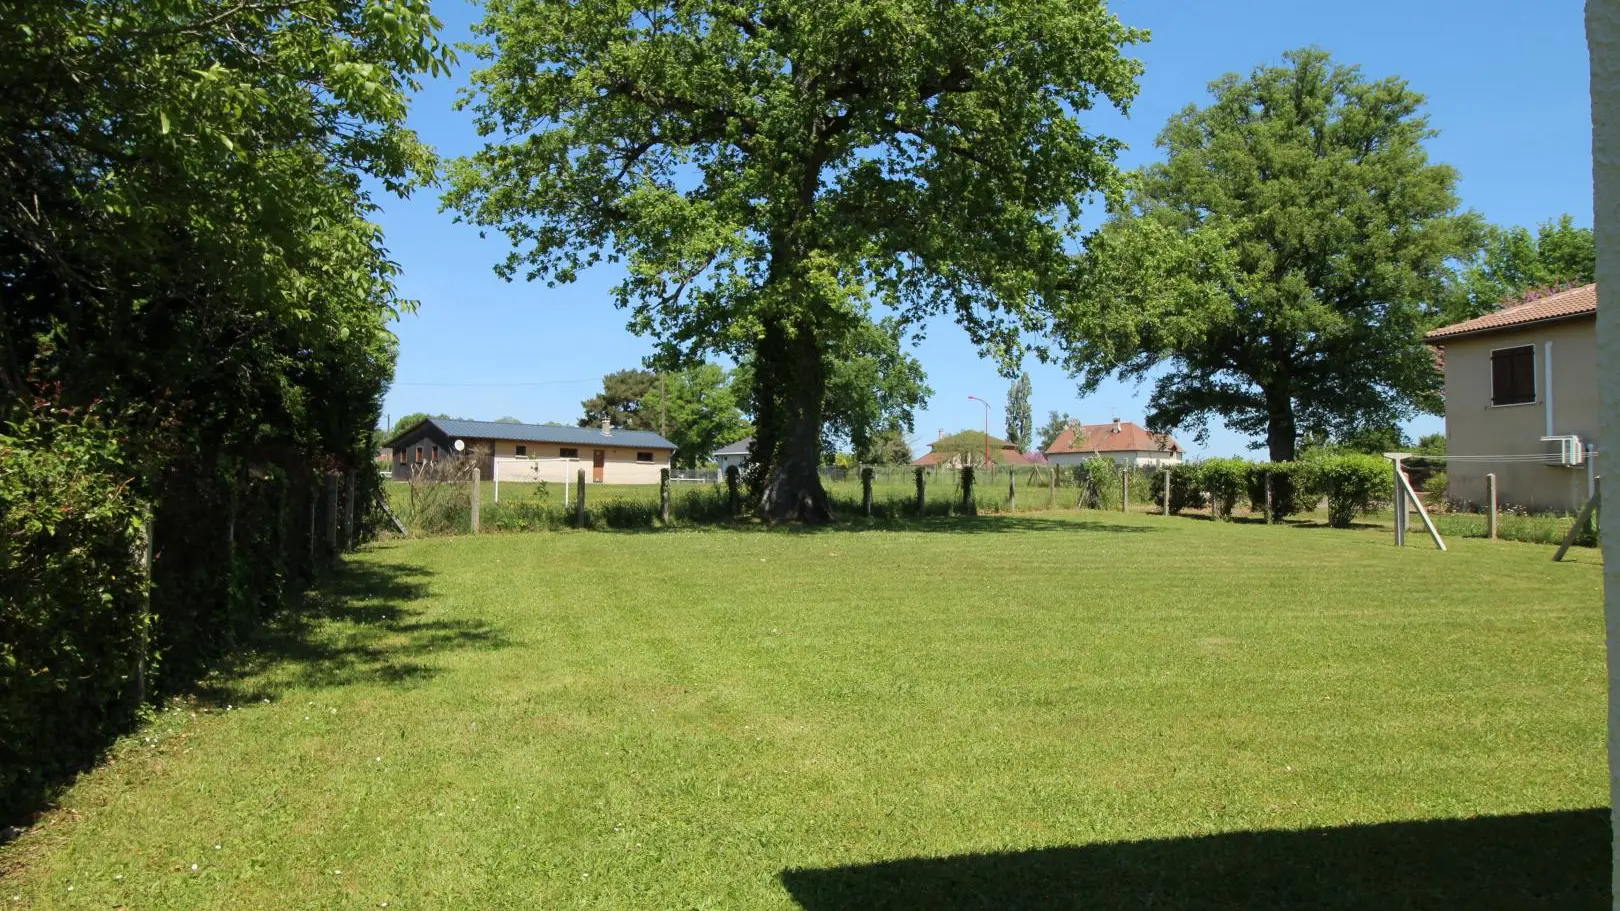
[{"x1": 447, "y1": 0, "x2": 1142, "y2": 522}]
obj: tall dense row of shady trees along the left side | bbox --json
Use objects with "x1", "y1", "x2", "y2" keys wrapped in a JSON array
[{"x1": 0, "y1": 0, "x2": 450, "y2": 820}]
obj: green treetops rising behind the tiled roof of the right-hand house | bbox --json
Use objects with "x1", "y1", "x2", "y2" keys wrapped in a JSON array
[{"x1": 1435, "y1": 214, "x2": 1597, "y2": 326}]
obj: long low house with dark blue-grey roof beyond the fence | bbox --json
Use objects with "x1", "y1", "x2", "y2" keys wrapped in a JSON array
[{"x1": 384, "y1": 418, "x2": 676, "y2": 485}]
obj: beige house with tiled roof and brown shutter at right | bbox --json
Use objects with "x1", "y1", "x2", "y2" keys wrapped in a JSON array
[{"x1": 1424, "y1": 285, "x2": 1601, "y2": 512}]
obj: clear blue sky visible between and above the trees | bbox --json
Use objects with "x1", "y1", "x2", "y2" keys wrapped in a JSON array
[{"x1": 377, "y1": 0, "x2": 1592, "y2": 456}]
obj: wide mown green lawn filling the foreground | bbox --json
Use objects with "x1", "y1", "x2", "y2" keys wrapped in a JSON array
[{"x1": 0, "y1": 512, "x2": 1609, "y2": 911}]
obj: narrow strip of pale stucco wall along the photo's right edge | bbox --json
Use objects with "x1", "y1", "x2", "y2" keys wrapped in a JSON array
[{"x1": 1586, "y1": 0, "x2": 1620, "y2": 909}]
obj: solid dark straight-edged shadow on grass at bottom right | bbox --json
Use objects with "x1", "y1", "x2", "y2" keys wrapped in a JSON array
[{"x1": 781, "y1": 809, "x2": 1609, "y2": 911}]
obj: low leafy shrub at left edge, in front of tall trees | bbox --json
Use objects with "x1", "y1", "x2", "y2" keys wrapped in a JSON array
[{"x1": 0, "y1": 403, "x2": 146, "y2": 820}]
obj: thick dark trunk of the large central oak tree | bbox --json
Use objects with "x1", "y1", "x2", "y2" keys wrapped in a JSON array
[{"x1": 750, "y1": 319, "x2": 833, "y2": 525}]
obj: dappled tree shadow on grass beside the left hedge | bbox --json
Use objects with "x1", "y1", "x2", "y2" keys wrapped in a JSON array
[{"x1": 193, "y1": 544, "x2": 509, "y2": 705}]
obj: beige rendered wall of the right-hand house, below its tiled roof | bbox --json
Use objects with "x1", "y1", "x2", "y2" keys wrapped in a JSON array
[{"x1": 1445, "y1": 319, "x2": 1601, "y2": 512}]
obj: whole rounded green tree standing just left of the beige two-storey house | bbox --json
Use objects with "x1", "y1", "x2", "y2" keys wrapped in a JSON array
[{"x1": 1064, "y1": 50, "x2": 1477, "y2": 462}]
